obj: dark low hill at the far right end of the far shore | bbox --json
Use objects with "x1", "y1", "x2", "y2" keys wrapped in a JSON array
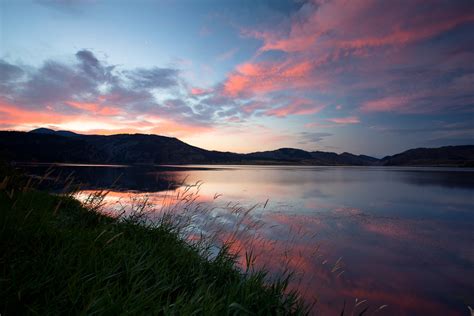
[{"x1": 381, "y1": 145, "x2": 474, "y2": 166}]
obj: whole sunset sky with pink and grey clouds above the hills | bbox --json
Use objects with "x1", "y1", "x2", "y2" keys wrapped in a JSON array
[{"x1": 0, "y1": 0, "x2": 474, "y2": 157}]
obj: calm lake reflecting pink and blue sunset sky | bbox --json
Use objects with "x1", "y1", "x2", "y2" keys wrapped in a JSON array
[{"x1": 19, "y1": 165, "x2": 474, "y2": 315}]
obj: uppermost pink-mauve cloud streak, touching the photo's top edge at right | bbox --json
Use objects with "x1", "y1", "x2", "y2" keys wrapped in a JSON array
[{"x1": 248, "y1": 0, "x2": 474, "y2": 53}]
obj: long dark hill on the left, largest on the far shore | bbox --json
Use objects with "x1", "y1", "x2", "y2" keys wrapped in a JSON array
[{"x1": 0, "y1": 131, "x2": 240, "y2": 164}]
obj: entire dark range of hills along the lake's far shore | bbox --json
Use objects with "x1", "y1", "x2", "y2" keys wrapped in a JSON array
[{"x1": 0, "y1": 128, "x2": 474, "y2": 166}]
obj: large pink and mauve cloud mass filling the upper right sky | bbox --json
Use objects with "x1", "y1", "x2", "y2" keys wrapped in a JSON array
[{"x1": 228, "y1": 0, "x2": 474, "y2": 114}]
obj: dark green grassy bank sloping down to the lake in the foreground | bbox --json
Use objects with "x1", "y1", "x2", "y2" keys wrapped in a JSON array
[{"x1": 0, "y1": 168, "x2": 307, "y2": 316}]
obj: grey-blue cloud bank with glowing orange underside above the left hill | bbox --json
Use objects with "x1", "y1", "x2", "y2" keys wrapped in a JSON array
[{"x1": 0, "y1": 50, "x2": 222, "y2": 135}]
